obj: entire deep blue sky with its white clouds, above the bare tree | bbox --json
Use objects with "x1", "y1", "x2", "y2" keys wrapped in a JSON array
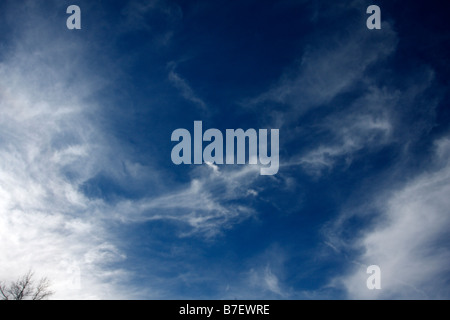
[{"x1": 0, "y1": 0, "x2": 450, "y2": 299}]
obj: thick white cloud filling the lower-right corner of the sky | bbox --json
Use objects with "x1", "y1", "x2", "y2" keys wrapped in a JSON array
[{"x1": 331, "y1": 138, "x2": 450, "y2": 299}]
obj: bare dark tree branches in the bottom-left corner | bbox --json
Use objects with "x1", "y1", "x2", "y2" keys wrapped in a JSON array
[{"x1": 0, "y1": 271, "x2": 53, "y2": 300}]
